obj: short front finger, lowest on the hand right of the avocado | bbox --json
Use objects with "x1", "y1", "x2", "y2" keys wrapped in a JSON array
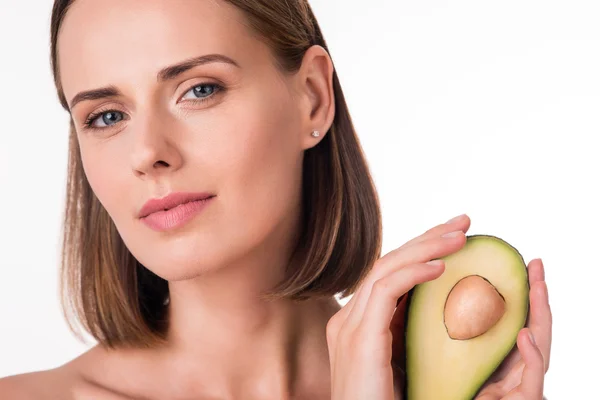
[{"x1": 517, "y1": 328, "x2": 545, "y2": 399}]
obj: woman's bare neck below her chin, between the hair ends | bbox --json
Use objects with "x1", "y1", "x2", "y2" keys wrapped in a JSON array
[{"x1": 162, "y1": 230, "x2": 339, "y2": 399}]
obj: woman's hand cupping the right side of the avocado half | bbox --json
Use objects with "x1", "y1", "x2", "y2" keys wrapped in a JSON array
[{"x1": 475, "y1": 259, "x2": 552, "y2": 400}]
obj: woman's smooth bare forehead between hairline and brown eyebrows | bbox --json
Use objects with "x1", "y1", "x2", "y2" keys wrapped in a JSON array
[{"x1": 58, "y1": 0, "x2": 265, "y2": 104}]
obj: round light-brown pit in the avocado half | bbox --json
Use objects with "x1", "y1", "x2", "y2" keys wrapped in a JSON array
[{"x1": 444, "y1": 275, "x2": 506, "y2": 340}]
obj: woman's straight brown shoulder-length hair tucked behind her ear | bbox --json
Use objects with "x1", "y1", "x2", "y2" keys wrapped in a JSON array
[{"x1": 50, "y1": 0, "x2": 382, "y2": 347}]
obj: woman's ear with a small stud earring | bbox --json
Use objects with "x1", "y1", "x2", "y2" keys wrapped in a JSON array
[{"x1": 297, "y1": 45, "x2": 335, "y2": 149}]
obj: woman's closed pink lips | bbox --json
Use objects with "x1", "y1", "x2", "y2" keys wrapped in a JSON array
[{"x1": 138, "y1": 192, "x2": 215, "y2": 231}]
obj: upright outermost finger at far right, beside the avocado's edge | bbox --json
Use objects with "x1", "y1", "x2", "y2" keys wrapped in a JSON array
[{"x1": 529, "y1": 281, "x2": 552, "y2": 371}]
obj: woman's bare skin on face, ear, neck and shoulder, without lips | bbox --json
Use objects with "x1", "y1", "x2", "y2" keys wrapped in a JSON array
[{"x1": 0, "y1": 0, "x2": 340, "y2": 400}]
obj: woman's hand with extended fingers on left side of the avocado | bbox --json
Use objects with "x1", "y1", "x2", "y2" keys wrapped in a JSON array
[{"x1": 327, "y1": 216, "x2": 471, "y2": 400}]
